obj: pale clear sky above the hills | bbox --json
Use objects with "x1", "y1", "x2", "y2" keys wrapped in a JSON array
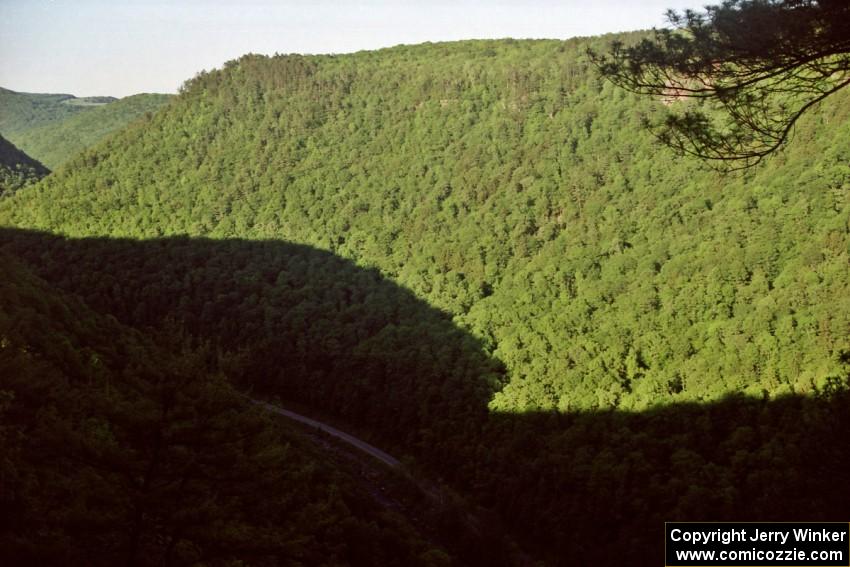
[{"x1": 0, "y1": 0, "x2": 712, "y2": 96}]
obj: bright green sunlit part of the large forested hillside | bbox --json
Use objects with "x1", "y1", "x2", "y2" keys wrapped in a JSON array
[{"x1": 0, "y1": 40, "x2": 850, "y2": 411}]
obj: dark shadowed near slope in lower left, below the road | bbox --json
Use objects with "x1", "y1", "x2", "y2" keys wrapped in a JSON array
[{"x1": 0, "y1": 252, "x2": 464, "y2": 565}]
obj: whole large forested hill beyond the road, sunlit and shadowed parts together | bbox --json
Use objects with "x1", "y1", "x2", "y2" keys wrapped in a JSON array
[{"x1": 0, "y1": 35, "x2": 850, "y2": 565}]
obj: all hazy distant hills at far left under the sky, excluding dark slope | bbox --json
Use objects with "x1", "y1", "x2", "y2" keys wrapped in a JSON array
[{"x1": 0, "y1": 89, "x2": 171, "y2": 169}]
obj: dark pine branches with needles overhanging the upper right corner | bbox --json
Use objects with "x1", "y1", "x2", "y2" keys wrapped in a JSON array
[{"x1": 591, "y1": 0, "x2": 850, "y2": 167}]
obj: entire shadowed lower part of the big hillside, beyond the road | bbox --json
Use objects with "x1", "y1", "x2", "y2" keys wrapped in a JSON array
[{"x1": 0, "y1": 228, "x2": 850, "y2": 565}]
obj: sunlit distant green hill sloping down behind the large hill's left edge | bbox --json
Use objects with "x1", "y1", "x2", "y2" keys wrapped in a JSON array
[{"x1": 6, "y1": 94, "x2": 171, "y2": 169}]
